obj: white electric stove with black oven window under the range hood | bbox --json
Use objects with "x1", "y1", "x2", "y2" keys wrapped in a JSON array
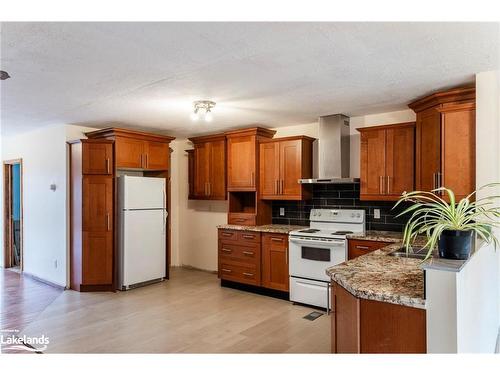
[{"x1": 289, "y1": 209, "x2": 366, "y2": 311}]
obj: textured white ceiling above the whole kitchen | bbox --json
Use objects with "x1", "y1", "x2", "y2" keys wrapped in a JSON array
[{"x1": 0, "y1": 23, "x2": 499, "y2": 136}]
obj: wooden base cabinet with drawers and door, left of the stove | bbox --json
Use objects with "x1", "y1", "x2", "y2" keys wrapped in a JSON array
[{"x1": 218, "y1": 229, "x2": 289, "y2": 292}]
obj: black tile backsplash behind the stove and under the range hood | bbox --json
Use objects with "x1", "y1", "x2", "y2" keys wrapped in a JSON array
[{"x1": 273, "y1": 183, "x2": 408, "y2": 232}]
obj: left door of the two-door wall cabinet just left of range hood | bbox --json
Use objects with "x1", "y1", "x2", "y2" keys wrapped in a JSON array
[{"x1": 259, "y1": 142, "x2": 280, "y2": 199}]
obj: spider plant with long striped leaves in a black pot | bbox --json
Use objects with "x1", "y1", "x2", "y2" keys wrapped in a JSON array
[{"x1": 393, "y1": 183, "x2": 500, "y2": 259}]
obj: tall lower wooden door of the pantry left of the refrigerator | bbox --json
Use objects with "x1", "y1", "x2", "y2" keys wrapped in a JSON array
[{"x1": 82, "y1": 176, "x2": 113, "y2": 285}]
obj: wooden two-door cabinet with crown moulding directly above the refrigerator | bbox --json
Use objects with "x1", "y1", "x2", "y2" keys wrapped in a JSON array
[{"x1": 86, "y1": 128, "x2": 175, "y2": 171}]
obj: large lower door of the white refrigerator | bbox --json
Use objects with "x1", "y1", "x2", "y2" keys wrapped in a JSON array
[{"x1": 120, "y1": 210, "x2": 167, "y2": 287}]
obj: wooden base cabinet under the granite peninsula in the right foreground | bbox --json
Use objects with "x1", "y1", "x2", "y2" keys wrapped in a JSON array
[{"x1": 331, "y1": 282, "x2": 427, "y2": 353}]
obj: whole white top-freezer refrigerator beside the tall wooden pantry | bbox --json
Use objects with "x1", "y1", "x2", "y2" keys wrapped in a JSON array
[{"x1": 118, "y1": 176, "x2": 168, "y2": 290}]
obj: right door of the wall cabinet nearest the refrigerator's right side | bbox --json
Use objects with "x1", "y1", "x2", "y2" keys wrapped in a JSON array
[{"x1": 208, "y1": 140, "x2": 226, "y2": 200}]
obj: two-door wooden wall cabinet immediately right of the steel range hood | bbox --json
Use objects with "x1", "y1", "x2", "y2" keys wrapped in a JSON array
[{"x1": 357, "y1": 122, "x2": 415, "y2": 201}]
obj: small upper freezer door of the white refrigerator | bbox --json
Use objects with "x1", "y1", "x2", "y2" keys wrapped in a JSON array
[{"x1": 118, "y1": 176, "x2": 166, "y2": 210}]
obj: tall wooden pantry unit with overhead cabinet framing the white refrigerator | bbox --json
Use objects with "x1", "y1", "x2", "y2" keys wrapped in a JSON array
[{"x1": 70, "y1": 128, "x2": 174, "y2": 292}]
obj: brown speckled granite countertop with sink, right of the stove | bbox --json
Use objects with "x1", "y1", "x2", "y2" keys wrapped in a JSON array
[{"x1": 326, "y1": 236, "x2": 425, "y2": 309}]
